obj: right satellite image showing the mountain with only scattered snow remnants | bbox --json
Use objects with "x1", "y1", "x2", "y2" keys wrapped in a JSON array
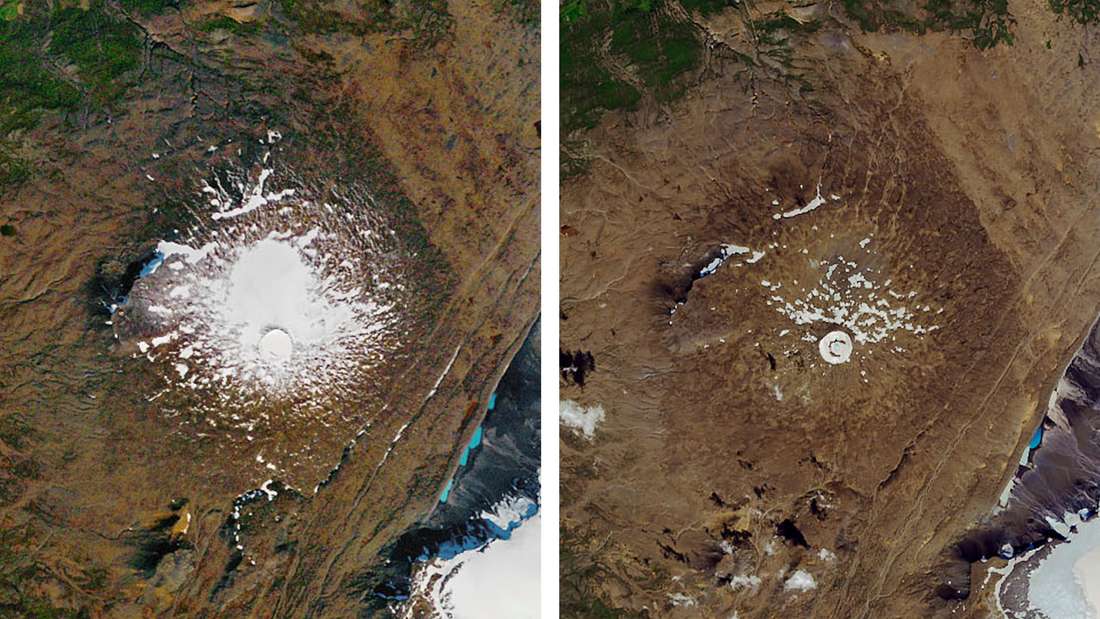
[{"x1": 559, "y1": 0, "x2": 1100, "y2": 619}]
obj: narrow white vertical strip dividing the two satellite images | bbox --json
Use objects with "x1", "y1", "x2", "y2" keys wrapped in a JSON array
[{"x1": 540, "y1": 0, "x2": 560, "y2": 619}]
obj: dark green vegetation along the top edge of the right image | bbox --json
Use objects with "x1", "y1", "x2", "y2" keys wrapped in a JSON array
[{"x1": 559, "y1": 0, "x2": 1051, "y2": 141}]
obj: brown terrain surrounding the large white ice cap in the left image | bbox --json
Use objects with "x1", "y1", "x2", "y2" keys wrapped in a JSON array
[{"x1": 0, "y1": 0, "x2": 539, "y2": 617}]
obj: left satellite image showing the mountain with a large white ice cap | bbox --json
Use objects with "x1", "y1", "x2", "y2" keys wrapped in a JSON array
[{"x1": 0, "y1": 0, "x2": 541, "y2": 619}]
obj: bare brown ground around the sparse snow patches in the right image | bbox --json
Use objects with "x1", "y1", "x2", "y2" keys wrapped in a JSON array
[{"x1": 561, "y1": 2, "x2": 1100, "y2": 619}]
